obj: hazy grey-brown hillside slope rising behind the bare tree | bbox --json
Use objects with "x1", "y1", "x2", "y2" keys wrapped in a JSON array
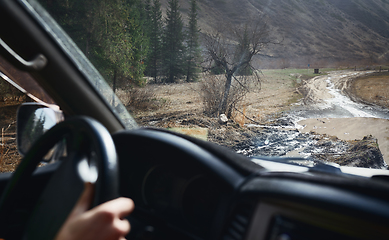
[{"x1": 167, "y1": 0, "x2": 389, "y2": 67}]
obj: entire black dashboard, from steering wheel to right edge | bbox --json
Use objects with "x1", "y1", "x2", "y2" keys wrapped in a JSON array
[{"x1": 113, "y1": 130, "x2": 389, "y2": 240}]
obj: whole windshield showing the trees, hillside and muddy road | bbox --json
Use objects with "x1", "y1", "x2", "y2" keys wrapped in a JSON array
[{"x1": 2, "y1": 0, "x2": 389, "y2": 172}]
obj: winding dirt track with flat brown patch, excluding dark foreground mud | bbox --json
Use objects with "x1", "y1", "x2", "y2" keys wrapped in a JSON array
[{"x1": 295, "y1": 71, "x2": 389, "y2": 164}]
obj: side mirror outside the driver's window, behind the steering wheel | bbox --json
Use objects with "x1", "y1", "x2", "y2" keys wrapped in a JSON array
[{"x1": 16, "y1": 103, "x2": 64, "y2": 156}]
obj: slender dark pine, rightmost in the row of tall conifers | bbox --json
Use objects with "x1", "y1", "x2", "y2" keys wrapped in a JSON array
[{"x1": 185, "y1": 0, "x2": 201, "y2": 82}]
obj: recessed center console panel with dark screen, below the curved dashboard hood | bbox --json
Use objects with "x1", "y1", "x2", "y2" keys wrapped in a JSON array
[{"x1": 247, "y1": 199, "x2": 388, "y2": 240}]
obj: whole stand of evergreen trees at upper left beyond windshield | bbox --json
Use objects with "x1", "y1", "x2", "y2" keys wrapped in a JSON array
[{"x1": 41, "y1": 0, "x2": 201, "y2": 91}]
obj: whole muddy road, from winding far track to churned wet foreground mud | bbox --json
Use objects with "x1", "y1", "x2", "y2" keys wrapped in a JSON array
[{"x1": 242, "y1": 71, "x2": 389, "y2": 169}]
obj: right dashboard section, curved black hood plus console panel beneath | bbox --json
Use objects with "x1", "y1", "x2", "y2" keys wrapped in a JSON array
[{"x1": 241, "y1": 176, "x2": 389, "y2": 240}]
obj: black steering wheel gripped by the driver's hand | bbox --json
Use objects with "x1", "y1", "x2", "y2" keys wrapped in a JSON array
[{"x1": 0, "y1": 117, "x2": 119, "y2": 239}]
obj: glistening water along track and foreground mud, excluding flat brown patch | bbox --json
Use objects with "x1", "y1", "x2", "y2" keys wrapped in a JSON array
[{"x1": 238, "y1": 71, "x2": 389, "y2": 168}]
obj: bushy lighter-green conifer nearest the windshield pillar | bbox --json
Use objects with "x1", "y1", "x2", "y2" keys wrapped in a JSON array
[{"x1": 94, "y1": 0, "x2": 147, "y2": 88}]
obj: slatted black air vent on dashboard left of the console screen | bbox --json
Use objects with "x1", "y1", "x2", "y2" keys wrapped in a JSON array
[{"x1": 222, "y1": 202, "x2": 254, "y2": 240}]
